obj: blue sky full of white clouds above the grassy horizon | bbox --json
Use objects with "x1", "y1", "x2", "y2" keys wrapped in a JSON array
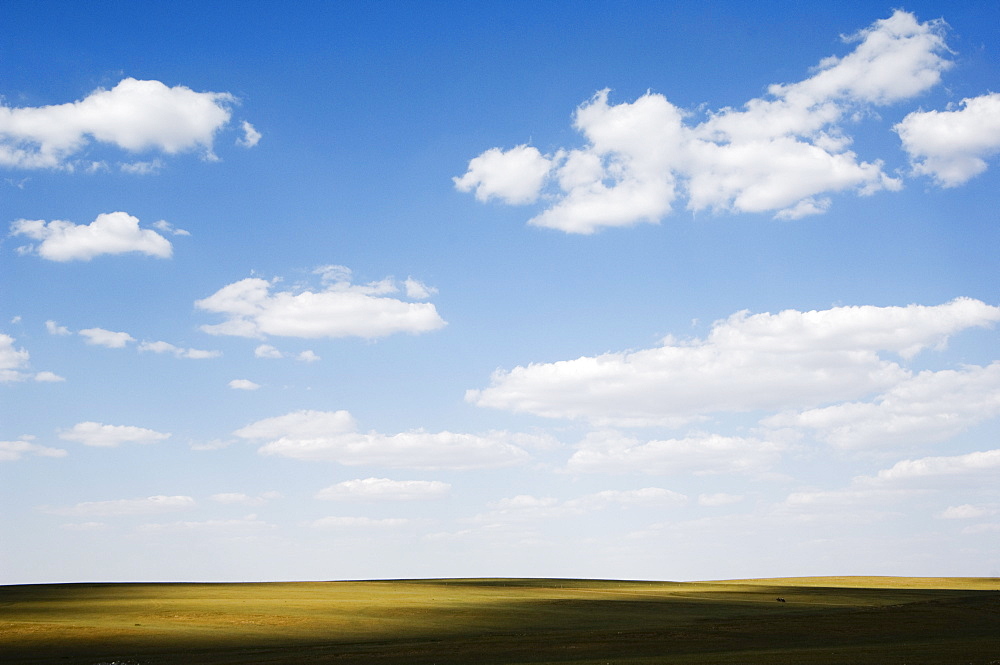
[{"x1": 0, "y1": 0, "x2": 1000, "y2": 584}]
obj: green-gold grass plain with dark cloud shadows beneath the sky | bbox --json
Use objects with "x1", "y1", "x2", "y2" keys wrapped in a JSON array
[{"x1": 0, "y1": 577, "x2": 1000, "y2": 665}]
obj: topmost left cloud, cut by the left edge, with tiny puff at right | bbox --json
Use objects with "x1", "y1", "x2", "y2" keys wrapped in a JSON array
[{"x1": 0, "y1": 78, "x2": 250, "y2": 170}]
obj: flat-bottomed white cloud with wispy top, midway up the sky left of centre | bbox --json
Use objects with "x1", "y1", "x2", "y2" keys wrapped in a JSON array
[{"x1": 195, "y1": 266, "x2": 446, "y2": 338}]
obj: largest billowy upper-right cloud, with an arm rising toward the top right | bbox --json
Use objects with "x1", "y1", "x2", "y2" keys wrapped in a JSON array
[{"x1": 454, "y1": 11, "x2": 951, "y2": 233}]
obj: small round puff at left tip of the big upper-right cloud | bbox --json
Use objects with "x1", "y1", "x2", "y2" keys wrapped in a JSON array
[{"x1": 452, "y1": 145, "x2": 552, "y2": 204}]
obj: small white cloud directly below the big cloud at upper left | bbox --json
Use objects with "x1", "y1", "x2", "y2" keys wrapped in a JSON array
[{"x1": 11, "y1": 212, "x2": 173, "y2": 261}]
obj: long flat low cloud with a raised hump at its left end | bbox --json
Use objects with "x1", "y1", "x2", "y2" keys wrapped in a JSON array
[{"x1": 235, "y1": 411, "x2": 545, "y2": 469}]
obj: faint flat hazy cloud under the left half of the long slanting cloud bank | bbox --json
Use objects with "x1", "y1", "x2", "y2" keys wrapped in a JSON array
[{"x1": 566, "y1": 431, "x2": 785, "y2": 475}]
